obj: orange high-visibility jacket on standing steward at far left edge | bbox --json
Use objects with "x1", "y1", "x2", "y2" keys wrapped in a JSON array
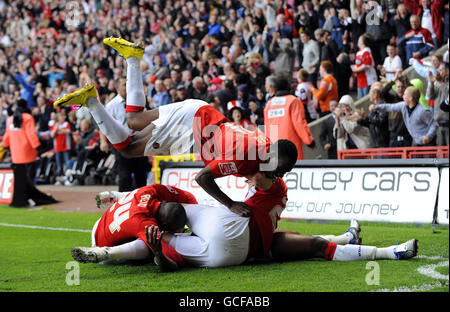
[{"x1": 3, "y1": 113, "x2": 41, "y2": 164}]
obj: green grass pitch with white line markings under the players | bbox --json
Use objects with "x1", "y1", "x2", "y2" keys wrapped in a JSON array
[{"x1": 0, "y1": 206, "x2": 449, "y2": 292}]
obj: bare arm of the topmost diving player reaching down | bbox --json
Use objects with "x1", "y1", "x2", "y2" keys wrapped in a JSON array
[{"x1": 195, "y1": 165, "x2": 251, "y2": 217}]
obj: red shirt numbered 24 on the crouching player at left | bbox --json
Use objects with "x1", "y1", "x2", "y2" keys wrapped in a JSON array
[{"x1": 95, "y1": 184, "x2": 197, "y2": 265}]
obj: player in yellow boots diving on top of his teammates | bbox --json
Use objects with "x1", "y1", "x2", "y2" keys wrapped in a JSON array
[{"x1": 54, "y1": 37, "x2": 297, "y2": 216}]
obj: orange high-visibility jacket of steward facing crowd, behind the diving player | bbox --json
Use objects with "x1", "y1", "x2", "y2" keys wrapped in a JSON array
[{"x1": 264, "y1": 95, "x2": 314, "y2": 159}]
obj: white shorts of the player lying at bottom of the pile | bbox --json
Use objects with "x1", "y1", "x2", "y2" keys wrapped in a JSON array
[{"x1": 169, "y1": 205, "x2": 250, "y2": 267}]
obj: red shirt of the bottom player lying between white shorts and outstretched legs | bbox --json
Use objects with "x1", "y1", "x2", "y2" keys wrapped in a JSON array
[{"x1": 245, "y1": 178, "x2": 287, "y2": 257}]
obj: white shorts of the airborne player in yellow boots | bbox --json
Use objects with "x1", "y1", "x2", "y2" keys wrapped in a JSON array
[{"x1": 144, "y1": 100, "x2": 209, "y2": 156}]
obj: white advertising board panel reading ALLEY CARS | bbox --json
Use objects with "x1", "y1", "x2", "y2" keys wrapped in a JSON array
[{"x1": 281, "y1": 167, "x2": 439, "y2": 223}]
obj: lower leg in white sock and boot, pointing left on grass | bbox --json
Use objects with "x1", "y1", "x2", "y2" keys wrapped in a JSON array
[{"x1": 71, "y1": 239, "x2": 153, "y2": 264}]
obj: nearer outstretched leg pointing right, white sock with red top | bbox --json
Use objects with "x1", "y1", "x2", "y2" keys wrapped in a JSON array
[{"x1": 271, "y1": 232, "x2": 417, "y2": 261}]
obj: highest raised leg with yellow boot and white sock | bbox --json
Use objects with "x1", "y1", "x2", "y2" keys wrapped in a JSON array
[{"x1": 103, "y1": 37, "x2": 159, "y2": 131}]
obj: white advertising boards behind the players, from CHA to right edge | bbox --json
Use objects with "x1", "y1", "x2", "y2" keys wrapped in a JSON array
[{"x1": 160, "y1": 158, "x2": 449, "y2": 225}]
